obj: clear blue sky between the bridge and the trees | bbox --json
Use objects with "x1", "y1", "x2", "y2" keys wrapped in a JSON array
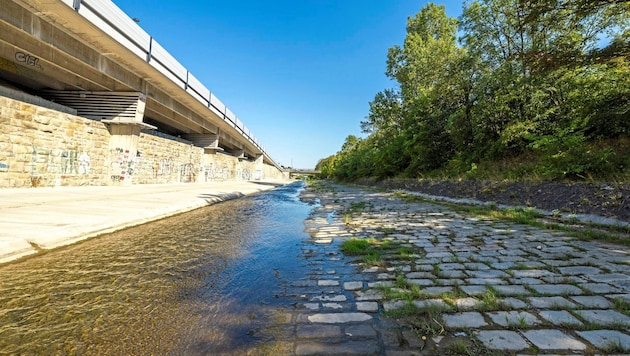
[{"x1": 113, "y1": 0, "x2": 463, "y2": 168}]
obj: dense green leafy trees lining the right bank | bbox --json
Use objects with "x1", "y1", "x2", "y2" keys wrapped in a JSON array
[{"x1": 317, "y1": 0, "x2": 630, "y2": 180}]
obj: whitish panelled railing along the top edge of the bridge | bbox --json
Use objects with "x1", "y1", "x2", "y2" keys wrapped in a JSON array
[{"x1": 61, "y1": 0, "x2": 277, "y2": 166}]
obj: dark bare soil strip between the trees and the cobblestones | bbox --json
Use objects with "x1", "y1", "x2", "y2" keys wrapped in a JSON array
[{"x1": 357, "y1": 179, "x2": 630, "y2": 222}]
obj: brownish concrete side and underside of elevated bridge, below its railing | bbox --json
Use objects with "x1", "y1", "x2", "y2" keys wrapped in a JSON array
[{"x1": 0, "y1": 0, "x2": 277, "y2": 167}]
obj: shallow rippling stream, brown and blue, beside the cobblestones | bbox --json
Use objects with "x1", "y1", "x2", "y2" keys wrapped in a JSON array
[{"x1": 0, "y1": 183, "x2": 312, "y2": 355}]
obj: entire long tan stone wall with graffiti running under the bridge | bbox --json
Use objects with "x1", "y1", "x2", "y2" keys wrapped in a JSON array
[{"x1": 0, "y1": 96, "x2": 282, "y2": 188}]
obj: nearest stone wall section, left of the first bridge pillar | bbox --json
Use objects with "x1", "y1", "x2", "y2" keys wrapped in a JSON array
[{"x1": 0, "y1": 96, "x2": 110, "y2": 187}]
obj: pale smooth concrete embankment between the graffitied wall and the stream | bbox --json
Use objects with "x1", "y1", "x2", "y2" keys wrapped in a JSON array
[{"x1": 0, "y1": 181, "x2": 289, "y2": 263}]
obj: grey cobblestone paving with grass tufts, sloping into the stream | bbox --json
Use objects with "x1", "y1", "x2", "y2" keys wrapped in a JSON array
[{"x1": 261, "y1": 186, "x2": 630, "y2": 356}]
